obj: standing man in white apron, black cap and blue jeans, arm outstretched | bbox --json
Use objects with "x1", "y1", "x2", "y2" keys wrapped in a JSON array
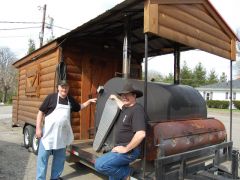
[{"x1": 36, "y1": 81, "x2": 96, "y2": 180}]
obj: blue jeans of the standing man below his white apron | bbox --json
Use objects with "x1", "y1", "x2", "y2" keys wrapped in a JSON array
[{"x1": 36, "y1": 140, "x2": 66, "y2": 180}]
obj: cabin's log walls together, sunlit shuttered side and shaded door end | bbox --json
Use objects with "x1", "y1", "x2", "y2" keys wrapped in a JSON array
[{"x1": 14, "y1": 43, "x2": 141, "y2": 140}]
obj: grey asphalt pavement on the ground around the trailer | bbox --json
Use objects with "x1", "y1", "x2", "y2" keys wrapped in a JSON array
[{"x1": 0, "y1": 105, "x2": 240, "y2": 180}]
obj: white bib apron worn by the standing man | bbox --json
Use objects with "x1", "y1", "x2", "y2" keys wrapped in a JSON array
[{"x1": 42, "y1": 94, "x2": 74, "y2": 150}]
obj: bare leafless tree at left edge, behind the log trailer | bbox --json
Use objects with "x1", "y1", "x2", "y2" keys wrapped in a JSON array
[{"x1": 0, "y1": 47, "x2": 16, "y2": 103}]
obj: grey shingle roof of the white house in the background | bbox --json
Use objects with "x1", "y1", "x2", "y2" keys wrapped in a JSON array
[{"x1": 196, "y1": 79, "x2": 240, "y2": 89}]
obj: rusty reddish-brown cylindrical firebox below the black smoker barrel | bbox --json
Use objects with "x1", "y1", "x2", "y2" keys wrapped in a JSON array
[{"x1": 146, "y1": 118, "x2": 227, "y2": 160}]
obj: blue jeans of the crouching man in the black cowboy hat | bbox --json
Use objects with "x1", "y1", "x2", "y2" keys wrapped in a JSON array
[{"x1": 95, "y1": 148, "x2": 140, "y2": 180}]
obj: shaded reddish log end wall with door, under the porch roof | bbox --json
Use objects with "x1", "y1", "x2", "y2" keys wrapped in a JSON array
[{"x1": 63, "y1": 48, "x2": 121, "y2": 140}]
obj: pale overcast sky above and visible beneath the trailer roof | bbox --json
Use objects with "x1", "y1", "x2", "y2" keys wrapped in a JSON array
[{"x1": 0, "y1": 0, "x2": 240, "y2": 77}]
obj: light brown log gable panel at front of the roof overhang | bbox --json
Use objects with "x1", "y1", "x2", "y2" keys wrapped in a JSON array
[{"x1": 144, "y1": 0, "x2": 236, "y2": 60}]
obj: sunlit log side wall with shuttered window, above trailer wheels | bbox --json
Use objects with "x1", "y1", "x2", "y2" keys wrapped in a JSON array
[{"x1": 13, "y1": 49, "x2": 59, "y2": 125}]
